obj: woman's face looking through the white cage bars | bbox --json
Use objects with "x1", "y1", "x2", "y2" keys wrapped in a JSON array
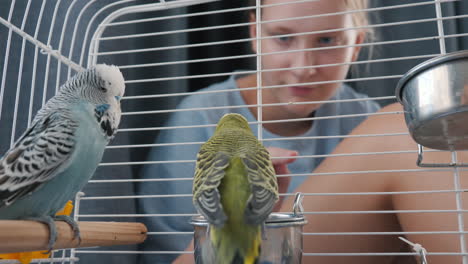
[{"x1": 250, "y1": 0, "x2": 364, "y2": 117}]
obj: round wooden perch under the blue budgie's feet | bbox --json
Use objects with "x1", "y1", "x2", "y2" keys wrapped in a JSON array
[{"x1": 0, "y1": 220, "x2": 147, "y2": 253}]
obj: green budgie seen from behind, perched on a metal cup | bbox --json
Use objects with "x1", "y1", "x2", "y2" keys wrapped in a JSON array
[{"x1": 193, "y1": 114, "x2": 278, "y2": 264}]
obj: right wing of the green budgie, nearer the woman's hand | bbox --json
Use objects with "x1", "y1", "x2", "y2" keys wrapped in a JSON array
[{"x1": 242, "y1": 143, "x2": 278, "y2": 225}]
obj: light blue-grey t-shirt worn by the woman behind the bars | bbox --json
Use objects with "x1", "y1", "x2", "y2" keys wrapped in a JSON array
[{"x1": 137, "y1": 72, "x2": 379, "y2": 263}]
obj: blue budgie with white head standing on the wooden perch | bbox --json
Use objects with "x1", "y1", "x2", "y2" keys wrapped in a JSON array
[{"x1": 0, "y1": 64, "x2": 125, "y2": 249}]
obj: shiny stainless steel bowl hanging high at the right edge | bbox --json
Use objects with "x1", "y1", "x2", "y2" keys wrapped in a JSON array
[{"x1": 396, "y1": 50, "x2": 468, "y2": 150}]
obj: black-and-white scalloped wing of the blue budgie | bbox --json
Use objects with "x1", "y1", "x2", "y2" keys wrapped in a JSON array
[{"x1": 0, "y1": 111, "x2": 77, "y2": 208}]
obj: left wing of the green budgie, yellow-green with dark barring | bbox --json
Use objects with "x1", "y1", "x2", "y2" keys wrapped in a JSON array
[{"x1": 193, "y1": 137, "x2": 230, "y2": 226}]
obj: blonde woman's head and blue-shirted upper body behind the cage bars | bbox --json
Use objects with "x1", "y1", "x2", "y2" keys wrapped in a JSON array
[{"x1": 138, "y1": 0, "x2": 379, "y2": 263}]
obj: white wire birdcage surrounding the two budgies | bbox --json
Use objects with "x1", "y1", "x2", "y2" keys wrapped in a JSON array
[{"x1": 0, "y1": 0, "x2": 468, "y2": 263}]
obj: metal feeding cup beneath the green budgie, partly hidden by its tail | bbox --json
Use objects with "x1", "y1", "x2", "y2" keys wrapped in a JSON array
[{"x1": 190, "y1": 193, "x2": 307, "y2": 264}]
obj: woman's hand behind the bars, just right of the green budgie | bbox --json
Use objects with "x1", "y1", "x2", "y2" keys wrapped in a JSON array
[{"x1": 267, "y1": 147, "x2": 298, "y2": 211}]
